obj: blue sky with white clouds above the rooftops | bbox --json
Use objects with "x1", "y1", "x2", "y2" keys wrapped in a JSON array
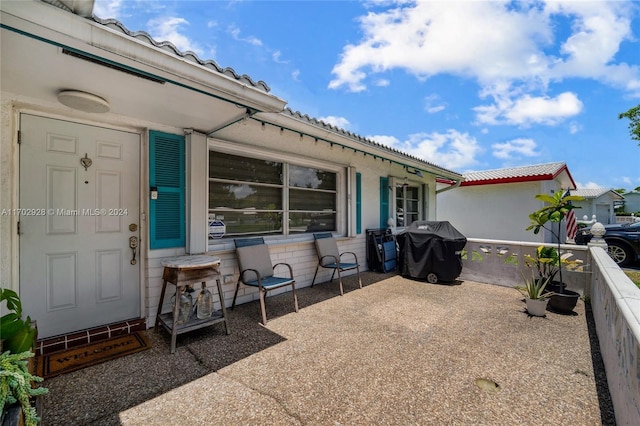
[{"x1": 94, "y1": 0, "x2": 640, "y2": 190}]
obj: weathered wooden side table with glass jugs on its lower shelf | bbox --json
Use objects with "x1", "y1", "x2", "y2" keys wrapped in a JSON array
[{"x1": 155, "y1": 256, "x2": 231, "y2": 353}]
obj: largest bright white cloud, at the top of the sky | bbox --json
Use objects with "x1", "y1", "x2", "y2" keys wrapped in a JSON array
[{"x1": 329, "y1": 1, "x2": 551, "y2": 91}]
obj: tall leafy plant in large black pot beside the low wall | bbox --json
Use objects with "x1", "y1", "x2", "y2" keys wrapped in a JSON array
[{"x1": 527, "y1": 190, "x2": 584, "y2": 313}]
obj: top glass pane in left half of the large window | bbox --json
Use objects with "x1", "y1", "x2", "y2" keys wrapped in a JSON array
[{"x1": 209, "y1": 151, "x2": 282, "y2": 185}]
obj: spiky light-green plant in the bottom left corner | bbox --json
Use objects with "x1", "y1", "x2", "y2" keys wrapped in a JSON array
[{"x1": 0, "y1": 351, "x2": 48, "y2": 426}]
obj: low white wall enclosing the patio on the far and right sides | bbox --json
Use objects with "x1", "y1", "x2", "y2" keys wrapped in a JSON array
[{"x1": 460, "y1": 238, "x2": 640, "y2": 425}]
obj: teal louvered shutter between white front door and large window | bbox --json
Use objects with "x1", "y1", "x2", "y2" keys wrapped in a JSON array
[{"x1": 149, "y1": 131, "x2": 186, "y2": 250}]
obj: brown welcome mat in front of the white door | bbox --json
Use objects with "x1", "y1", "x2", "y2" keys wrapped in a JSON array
[{"x1": 36, "y1": 333, "x2": 151, "y2": 379}]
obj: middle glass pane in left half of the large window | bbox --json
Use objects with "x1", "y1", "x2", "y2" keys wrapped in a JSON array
[{"x1": 209, "y1": 182, "x2": 282, "y2": 210}]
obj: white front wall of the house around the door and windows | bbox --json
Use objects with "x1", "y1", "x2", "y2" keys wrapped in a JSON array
[{"x1": 0, "y1": 92, "x2": 444, "y2": 326}]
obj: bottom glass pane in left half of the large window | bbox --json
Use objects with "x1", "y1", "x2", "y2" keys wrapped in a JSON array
[{"x1": 209, "y1": 211, "x2": 282, "y2": 237}]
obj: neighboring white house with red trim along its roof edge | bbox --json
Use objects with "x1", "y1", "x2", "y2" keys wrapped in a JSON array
[{"x1": 437, "y1": 162, "x2": 576, "y2": 242}]
